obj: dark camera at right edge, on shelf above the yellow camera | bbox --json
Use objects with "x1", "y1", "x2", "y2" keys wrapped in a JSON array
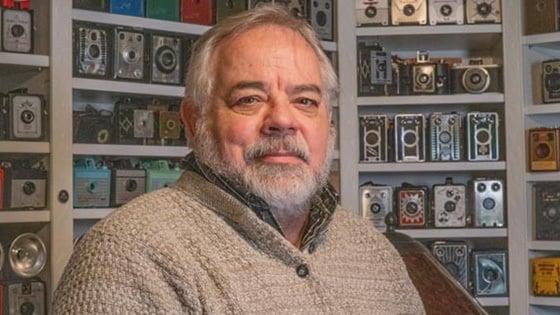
[{"x1": 533, "y1": 182, "x2": 560, "y2": 241}]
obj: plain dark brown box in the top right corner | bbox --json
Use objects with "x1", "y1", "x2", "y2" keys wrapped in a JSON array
[{"x1": 523, "y1": 0, "x2": 560, "y2": 35}]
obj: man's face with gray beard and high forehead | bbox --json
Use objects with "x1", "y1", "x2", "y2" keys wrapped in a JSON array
[{"x1": 190, "y1": 26, "x2": 332, "y2": 212}]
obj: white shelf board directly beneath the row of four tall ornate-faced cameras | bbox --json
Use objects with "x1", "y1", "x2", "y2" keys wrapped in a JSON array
[{"x1": 358, "y1": 161, "x2": 506, "y2": 173}]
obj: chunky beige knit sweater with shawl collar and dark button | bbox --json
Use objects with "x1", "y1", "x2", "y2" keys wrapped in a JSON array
[{"x1": 53, "y1": 172, "x2": 424, "y2": 314}]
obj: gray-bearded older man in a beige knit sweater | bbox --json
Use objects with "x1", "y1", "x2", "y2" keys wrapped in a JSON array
[{"x1": 54, "y1": 7, "x2": 424, "y2": 314}]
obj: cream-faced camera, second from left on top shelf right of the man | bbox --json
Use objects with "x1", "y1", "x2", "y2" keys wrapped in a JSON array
[{"x1": 391, "y1": 0, "x2": 428, "y2": 25}]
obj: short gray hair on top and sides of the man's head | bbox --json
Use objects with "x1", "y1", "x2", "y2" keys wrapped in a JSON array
[{"x1": 185, "y1": 5, "x2": 338, "y2": 118}]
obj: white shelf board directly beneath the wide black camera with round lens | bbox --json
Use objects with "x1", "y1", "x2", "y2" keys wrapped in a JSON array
[{"x1": 357, "y1": 93, "x2": 504, "y2": 106}]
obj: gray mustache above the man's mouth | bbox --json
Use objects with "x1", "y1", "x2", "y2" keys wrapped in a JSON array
[{"x1": 245, "y1": 136, "x2": 309, "y2": 162}]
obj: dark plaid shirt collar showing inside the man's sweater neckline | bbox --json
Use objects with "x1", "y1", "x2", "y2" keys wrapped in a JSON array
[{"x1": 183, "y1": 153, "x2": 338, "y2": 252}]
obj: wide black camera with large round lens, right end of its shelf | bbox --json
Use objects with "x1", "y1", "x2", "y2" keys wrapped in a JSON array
[{"x1": 450, "y1": 58, "x2": 502, "y2": 94}]
